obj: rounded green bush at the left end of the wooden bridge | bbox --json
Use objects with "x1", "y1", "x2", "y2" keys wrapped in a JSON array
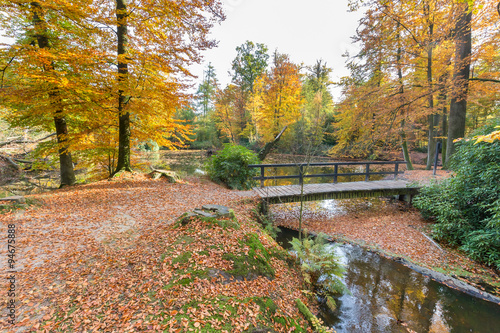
[{"x1": 205, "y1": 145, "x2": 260, "y2": 190}]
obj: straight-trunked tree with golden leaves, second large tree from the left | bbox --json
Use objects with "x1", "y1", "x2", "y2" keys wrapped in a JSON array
[{"x1": 101, "y1": 0, "x2": 224, "y2": 173}]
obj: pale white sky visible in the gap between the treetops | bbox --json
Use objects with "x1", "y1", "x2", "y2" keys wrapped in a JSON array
[{"x1": 189, "y1": 0, "x2": 361, "y2": 100}]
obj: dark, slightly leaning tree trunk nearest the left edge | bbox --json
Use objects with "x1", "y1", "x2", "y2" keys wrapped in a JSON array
[{"x1": 31, "y1": 1, "x2": 76, "y2": 187}]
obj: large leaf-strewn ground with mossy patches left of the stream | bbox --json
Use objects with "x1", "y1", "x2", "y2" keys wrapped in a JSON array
[{"x1": 0, "y1": 175, "x2": 310, "y2": 332}]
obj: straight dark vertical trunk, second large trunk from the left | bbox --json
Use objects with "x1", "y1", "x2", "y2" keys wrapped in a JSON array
[{"x1": 115, "y1": 0, "x2": 132, "y2": 174}]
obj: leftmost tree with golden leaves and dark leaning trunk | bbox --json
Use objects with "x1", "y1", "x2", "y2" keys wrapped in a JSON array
[{"x1": 0, "y1": 1, "x2": 96, "y2": 186}]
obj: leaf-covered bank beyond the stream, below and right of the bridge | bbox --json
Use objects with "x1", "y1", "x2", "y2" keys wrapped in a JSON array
[{"x1": 272, "y1": 165, "x2": 500, "y2": 297}]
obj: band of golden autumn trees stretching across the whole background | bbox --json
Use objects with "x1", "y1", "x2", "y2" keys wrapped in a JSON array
[{"x1": 0, "y1": 0, "x2": 500, "y2": 185}]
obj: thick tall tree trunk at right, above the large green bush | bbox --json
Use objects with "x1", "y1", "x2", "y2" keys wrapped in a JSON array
[{"x1": 446, "y1": 2, "x2": 472, "y2": 164}]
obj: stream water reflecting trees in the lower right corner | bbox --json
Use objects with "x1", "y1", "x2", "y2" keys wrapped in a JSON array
[{"x1": 278, "y1": 229, "x2": 500, "y2": 333}]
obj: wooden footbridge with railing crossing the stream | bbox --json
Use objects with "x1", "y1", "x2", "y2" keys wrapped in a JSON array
[{"x1": 249, "y1": 161, "x2": 419, "y2": 212}]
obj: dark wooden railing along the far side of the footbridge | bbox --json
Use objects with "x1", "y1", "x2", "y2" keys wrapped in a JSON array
[{"x1": 248, "y1": 161, "x2": 406, "y2": 187}]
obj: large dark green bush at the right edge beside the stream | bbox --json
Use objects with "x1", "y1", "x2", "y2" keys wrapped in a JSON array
[{"x1": 414, "y1": 120, "x2": 500, "y2": 269}]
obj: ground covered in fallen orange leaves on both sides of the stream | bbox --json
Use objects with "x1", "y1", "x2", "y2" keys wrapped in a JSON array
[{"x1": 0, "y1": 160, "x2": 500, "y2": 332}]
